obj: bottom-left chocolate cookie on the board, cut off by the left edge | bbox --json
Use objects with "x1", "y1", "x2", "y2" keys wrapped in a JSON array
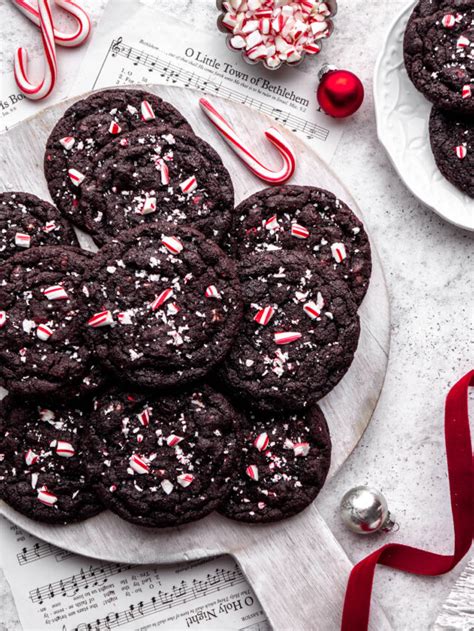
[{"x1": 0, "y1": 397, "x2": 102, "y2": 524}]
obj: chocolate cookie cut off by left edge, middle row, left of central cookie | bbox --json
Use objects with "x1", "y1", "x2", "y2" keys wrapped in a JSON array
[{"x1": 0, "y1": 246, "x2": 104, "y2": 399}]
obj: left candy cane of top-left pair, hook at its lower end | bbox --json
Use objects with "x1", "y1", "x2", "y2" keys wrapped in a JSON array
[{"x1": 15, "y1": 0, "x2": 57, "y2": 101}]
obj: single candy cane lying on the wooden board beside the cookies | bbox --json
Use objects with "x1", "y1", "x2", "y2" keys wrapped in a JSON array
[{"x1": 199, "y1": 98, "x2": 296, "y2": 184}]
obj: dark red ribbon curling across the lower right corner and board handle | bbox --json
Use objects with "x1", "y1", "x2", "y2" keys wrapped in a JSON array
[{"x1": 341, "y1": 370, "x2": 474, "y2": 631}]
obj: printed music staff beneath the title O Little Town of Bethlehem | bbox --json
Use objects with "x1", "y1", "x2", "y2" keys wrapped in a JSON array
[{"x1": 106, "y1": 38, "x2": 329, "y2": 141}]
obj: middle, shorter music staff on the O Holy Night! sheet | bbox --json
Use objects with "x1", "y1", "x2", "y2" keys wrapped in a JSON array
[{"x1": 29, "y1": 563, "x2": 136, "y2": 605}]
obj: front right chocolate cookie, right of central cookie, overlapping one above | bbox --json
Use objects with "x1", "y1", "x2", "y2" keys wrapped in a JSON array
[{"x1": 218, "y1": 252, "x2": 359, "y2": 410}]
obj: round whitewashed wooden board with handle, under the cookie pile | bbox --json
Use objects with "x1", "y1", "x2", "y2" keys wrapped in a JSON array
[{"x1": 0, "y1": 85, "x2": 390, "y2": 631}]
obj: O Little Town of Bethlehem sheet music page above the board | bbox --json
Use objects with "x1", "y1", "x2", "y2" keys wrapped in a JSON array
[{"x1": 73, "y1": 0, "x2": 343, "y2": 161}]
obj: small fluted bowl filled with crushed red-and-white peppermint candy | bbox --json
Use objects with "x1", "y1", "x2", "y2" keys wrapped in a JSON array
[{"x1": 217, "y1": 0, "x2": 337, "y2": 70}]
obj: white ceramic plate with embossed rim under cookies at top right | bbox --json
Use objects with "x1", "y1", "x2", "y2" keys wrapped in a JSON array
[{"x1": 374, "y1": 1, "x2": 474, "y2": 230}]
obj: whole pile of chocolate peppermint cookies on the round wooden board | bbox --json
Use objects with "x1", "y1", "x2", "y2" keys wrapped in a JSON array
[{"x1": 0, "y1": 90, "x2": 371, "y2": 527}]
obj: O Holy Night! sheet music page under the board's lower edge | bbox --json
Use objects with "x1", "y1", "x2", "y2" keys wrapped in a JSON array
[{"x1": 0, "y1": 518, "x2": 270, "y2": 631}]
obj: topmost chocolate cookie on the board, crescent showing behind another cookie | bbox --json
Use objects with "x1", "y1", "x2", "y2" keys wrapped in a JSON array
[{"x1": 44, "y1": 88, "x2": 192, "y2": 228}]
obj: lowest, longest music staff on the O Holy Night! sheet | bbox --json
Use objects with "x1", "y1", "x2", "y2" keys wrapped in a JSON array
[{"x1": 73, "y1": 565, "x2": 245, "y2": 631}]
